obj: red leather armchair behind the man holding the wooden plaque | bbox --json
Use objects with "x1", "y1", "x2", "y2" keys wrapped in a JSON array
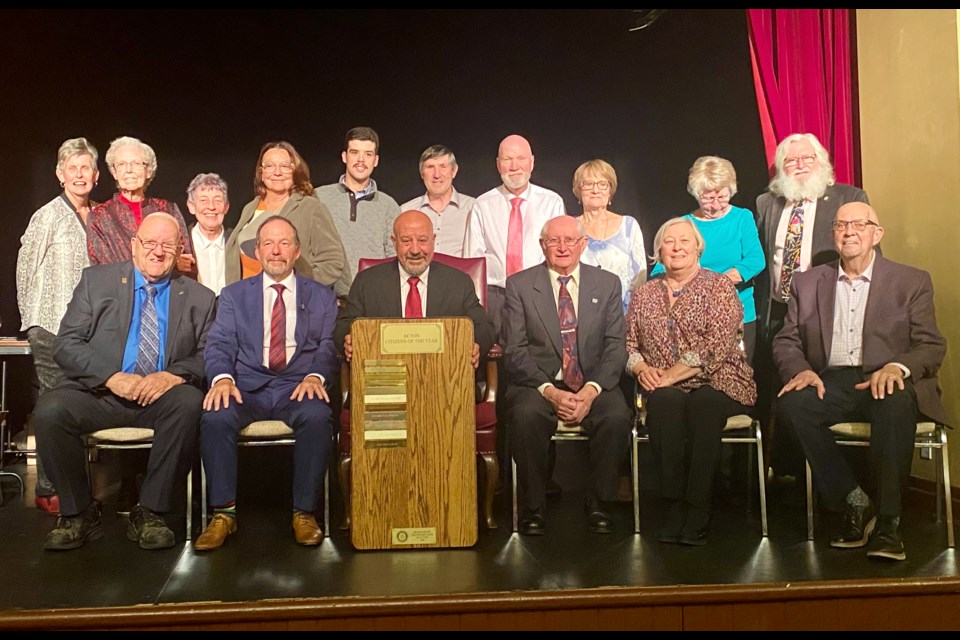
[{"x1": 337, "y1": 253, "x2": 502, "y2": 529}]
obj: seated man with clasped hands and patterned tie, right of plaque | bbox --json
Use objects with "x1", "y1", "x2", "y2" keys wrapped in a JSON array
[{"x1": 501, "y1": 216, "x2": 631, "y2": 535}]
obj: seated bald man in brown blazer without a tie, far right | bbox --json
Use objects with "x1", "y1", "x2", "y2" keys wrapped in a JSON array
[{"x1": 773, "y1": 202, "x2": 948, "y2": 560}]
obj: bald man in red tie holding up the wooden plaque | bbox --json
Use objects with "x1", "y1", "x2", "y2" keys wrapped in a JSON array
[{"x1": 334, "y1": 209, "x2": 494, "y2": 369}]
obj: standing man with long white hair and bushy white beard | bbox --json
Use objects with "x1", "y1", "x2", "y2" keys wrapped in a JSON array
[{"x1": 754, "y1": 133, "x2": 870, "y2": 478}]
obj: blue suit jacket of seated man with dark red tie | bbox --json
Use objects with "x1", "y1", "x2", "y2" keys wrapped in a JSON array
[{"x1": 203, "y1": 273, "x2": 338, "y2": 392}]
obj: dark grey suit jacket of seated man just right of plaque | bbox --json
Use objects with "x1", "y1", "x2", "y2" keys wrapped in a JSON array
[{"x1": 502, "y1": 262, "x2": 627, "y2": 391}]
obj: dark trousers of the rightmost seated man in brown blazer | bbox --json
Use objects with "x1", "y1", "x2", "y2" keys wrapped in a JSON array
[{"x1": 777, "y1": 367, "x2": 919, "y2": 516}]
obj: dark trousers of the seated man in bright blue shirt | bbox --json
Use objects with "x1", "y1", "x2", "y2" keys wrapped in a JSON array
[{"x1": 33, "y1": 384, "x2": 203, "y2": 516}]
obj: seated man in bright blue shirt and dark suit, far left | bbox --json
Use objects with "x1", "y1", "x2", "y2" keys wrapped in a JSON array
[{"x1": 34, "y1": 212, "x2": 216, "y2": 550}]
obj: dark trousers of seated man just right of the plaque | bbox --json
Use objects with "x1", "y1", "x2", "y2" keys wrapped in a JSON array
[{"x1": 504, "y1": 386, "x2": 633, "y2": 515}]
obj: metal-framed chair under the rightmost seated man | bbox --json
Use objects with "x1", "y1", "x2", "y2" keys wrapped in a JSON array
[{"x1": 806, "y1": 421, "x2": 954, "y2": 549}]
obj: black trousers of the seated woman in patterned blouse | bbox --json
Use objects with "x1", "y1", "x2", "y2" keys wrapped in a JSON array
[{"x1": 646, "y1": 385, "x2": 750, "y2": 512}]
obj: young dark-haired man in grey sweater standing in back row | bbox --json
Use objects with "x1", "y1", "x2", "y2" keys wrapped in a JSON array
[{"x1": 314, "y1": 127, "x2": 400, "y2": 299}]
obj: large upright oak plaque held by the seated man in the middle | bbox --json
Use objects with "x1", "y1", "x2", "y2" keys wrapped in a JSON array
[{"x1": 350, "y1": 317, "x2": 477, "y2": 549}]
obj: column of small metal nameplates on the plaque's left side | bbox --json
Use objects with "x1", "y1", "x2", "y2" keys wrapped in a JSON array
[{"x1": 363, "y1": 360, "x2": 407, "y2": 449}]
